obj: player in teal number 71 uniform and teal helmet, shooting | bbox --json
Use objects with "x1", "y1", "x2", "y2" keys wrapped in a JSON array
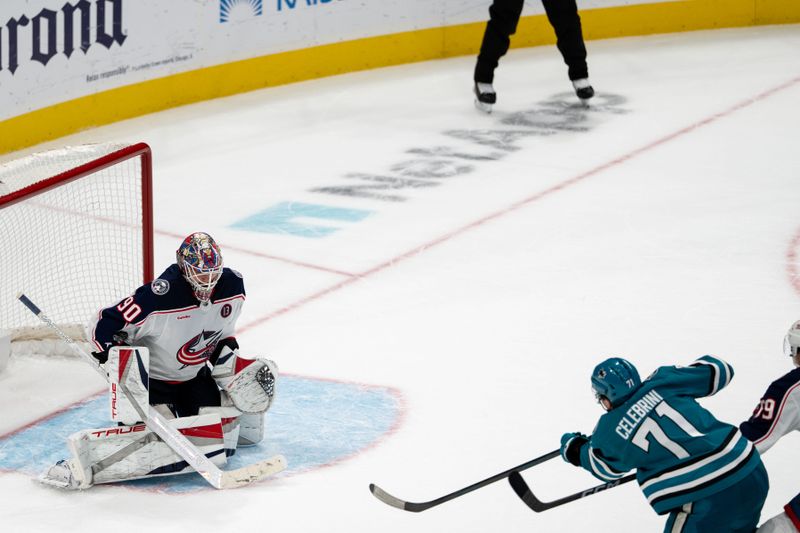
[{"x1": 561, "y1": 355, "x2": 769, "y2": 533}]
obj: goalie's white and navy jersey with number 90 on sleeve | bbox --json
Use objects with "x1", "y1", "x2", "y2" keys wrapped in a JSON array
[{"x1": 90, "y1": 264, "x2": 245, "y2": 382}]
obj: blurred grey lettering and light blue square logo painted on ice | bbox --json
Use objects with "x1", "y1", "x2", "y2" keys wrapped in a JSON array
[{"x1": 231, "y1": 93, "x2": 628, "y2": 238}]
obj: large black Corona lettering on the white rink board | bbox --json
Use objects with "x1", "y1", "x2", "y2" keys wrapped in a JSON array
[{"x1": 0, "y1": 0, "x2": 127, "y2": 74}]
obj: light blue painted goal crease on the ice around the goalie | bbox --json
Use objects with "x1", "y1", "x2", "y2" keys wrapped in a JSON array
[{"x1": 0, "y1": 376, "x2": 402, "y2": 493}]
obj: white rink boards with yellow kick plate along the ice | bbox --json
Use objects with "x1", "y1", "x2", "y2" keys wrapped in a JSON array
[{"x1": 0, "y1": 0, "x2": 800, "y2": 154}]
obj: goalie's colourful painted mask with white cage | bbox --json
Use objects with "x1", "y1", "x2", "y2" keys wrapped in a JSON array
[{"x1": 176, "y1": 232, "x2": 222, "y2": 302}]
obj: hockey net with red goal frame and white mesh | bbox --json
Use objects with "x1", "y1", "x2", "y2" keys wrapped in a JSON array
[{"x1": 0, "y1": 143, "x2": 153, "y2": 355}]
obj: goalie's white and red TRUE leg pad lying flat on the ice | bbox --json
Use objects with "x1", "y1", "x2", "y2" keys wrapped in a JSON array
[{"x1": 40, "y1": 413, "x2": 227, "y2": 488}]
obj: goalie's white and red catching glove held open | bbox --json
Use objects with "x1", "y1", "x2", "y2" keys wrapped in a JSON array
[{"x1": 211, "y1": 339, "x2": 278, "y2": 413}]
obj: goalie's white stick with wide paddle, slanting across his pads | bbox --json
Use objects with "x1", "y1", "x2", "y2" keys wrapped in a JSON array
[{"x1": 17, "y1": 293, "x2": 286, "y2": 489}]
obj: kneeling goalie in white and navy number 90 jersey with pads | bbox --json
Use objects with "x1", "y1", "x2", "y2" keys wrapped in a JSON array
[{"x1": 39, "y1": 233, "x2": 278, "y2": 489}]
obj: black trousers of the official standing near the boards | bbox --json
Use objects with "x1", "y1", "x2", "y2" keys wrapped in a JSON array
[{"x1": 475, "y1": 0, "x2": 589, "y2": 83}]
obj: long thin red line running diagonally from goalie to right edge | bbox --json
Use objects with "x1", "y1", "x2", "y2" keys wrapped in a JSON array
[{"x1": 238, "y1": 76, "x2": 800, "y2": 332}]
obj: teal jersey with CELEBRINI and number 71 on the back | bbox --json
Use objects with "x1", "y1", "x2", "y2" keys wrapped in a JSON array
[{"x1": 580, "y1": 355, "x2": 761, "y2": 514}]
